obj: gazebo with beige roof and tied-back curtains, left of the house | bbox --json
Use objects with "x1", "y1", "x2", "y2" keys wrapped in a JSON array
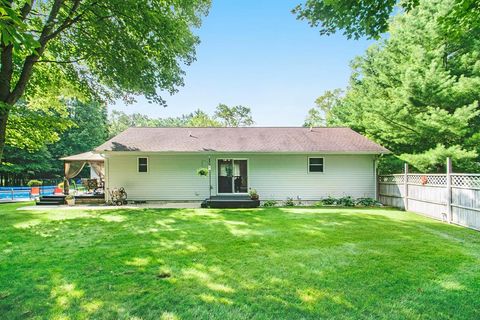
[{"x1": 60, "y1": 151, "x2": 105, "y2": 194}]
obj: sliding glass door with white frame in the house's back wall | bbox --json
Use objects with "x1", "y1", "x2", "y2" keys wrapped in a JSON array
[{"x1": 217, "y1": 159, "x2": 248, "y2": 194}]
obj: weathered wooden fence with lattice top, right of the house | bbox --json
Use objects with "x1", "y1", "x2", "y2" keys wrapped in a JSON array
[{"x1": 378, "y1": 161, "x2": 480, "y2": 230}]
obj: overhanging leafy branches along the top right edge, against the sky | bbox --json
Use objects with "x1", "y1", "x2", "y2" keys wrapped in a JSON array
[{"x1": 292, "y1": 0, "x2": 480, "y2": 39}]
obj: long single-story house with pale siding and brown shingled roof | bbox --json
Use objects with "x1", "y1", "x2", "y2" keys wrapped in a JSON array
[{"x1": 95, "y1": 127, "x2": 389, "y2": 201}]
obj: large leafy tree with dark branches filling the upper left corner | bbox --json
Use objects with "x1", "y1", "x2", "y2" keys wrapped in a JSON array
[{"x1": 0, "y1": 0, "x2": 209, "y2": 159}]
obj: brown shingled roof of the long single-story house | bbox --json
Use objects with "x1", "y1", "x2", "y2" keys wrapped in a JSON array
[{"x1": 95, "y1": 127, "x2": 389, "y2": 153}]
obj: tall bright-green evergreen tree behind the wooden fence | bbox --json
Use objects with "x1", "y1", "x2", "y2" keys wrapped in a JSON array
[{"x1": 331, "y1": 0, "x2": 480, "y2": 171}]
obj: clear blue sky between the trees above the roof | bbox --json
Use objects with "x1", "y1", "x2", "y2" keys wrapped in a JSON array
[{"x1": 110, "y1": 0, "x2": 371, "y2": 126}]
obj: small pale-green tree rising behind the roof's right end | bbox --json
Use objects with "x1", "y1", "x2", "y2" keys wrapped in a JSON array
[{"x1": 303, "y1": 89, "x2": 343, "y2": 127}]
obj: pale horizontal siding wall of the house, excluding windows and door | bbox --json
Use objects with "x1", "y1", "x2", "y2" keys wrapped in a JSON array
[{"x1": 106, "y1": 154, "x2": 375, "y2": 200}]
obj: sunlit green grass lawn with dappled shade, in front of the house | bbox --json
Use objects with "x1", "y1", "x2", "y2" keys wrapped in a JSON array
[{"x1": 0, "y1": 204, "x2": 480, "y2": 320}]
